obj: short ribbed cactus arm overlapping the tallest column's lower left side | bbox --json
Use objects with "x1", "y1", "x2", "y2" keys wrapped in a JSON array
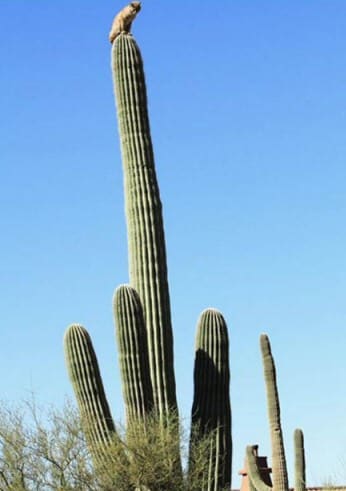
[{"x1": 114, "y1": 285, "x2": 153, "y2": 423}]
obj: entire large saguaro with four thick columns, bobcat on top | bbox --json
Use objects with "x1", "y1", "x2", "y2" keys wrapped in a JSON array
[{"x1": 65, "y1": 9, "x2": 232, "y2": 491}]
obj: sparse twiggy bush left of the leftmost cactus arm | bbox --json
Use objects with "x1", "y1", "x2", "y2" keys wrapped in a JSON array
[{"x1": 0, "y1": 399, "x2": 97, "y2": 491}]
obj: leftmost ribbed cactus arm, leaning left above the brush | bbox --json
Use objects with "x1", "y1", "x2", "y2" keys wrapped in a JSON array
[{"x1": 64, "y1": 324, "x2": 116, "y2": 458}]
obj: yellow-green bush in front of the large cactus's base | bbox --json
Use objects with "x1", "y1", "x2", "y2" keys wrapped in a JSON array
[{"x1": 86, "y1": 412, "x2": 231, "y2": 491}]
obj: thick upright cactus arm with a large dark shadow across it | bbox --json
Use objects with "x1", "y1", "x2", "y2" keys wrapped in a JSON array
[{"x1": 190, "y1": 309, "x2": 232, "y2": 491}]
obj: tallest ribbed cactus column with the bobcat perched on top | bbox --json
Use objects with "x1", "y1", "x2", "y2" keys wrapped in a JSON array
[{"x1": 112, "y1": 33, "x2": 177, "y2": 416}]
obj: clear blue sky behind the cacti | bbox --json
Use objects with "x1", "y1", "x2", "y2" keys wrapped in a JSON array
[{"x1": 0, "y1": 0, "x2": 346, "y2": 487}]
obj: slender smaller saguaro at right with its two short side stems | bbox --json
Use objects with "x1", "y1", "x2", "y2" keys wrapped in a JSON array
[{"x1": 246, "y1": 334, "x2": 305, "y2": 491}]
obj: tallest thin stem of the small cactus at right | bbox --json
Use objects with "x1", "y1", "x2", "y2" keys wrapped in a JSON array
[{"x1": 260, "y1": 334, "x2": 288, "y2": 491}]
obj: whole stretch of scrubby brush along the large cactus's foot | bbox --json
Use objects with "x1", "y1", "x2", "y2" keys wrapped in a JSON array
[{"x1": 0, "y1": 399, "x2": 228, "y2": 491}]
